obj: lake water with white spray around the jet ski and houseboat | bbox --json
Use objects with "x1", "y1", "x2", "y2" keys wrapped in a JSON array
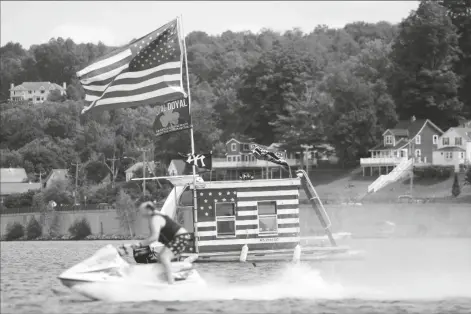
[{"x1": 1, "y1": 238, "x2": 471, "y2": 314}]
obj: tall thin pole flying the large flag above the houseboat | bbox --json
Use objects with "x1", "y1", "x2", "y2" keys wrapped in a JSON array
[{"x1": 178, "y1": 14, "x2": 199, "y2": 253}]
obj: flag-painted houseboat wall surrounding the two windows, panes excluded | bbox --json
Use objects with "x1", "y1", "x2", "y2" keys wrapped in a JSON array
[{"x1": 196, "y1": 179, "x2": 300, "y2": 253}]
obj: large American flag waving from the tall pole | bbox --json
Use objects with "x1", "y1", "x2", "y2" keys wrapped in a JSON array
[{"x1": 77, "y1": 19, "x2": 186, "y2": 114}]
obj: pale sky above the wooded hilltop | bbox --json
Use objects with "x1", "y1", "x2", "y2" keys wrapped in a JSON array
[{"x1": 0, "y1": 0, "x2": 419, "y2": 48}]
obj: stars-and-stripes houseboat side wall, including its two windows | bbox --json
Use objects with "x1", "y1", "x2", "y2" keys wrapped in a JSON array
[{"x1": 196, "y1": 181, "x2": 300, "y2": 252}]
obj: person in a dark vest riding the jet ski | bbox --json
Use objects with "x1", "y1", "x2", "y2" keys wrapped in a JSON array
[{"x1": 132, "y1": 201, "x2": 191, "y2": 284}]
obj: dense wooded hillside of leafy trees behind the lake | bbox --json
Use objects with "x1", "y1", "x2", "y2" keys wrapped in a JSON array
[{"x1": 0, "y1": 0, "x2": 471, "y2": 194}]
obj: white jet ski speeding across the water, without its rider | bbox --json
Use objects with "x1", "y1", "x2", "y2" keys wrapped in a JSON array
[{"x1": 58, "y1": 245, "x2": 205, "y2": 302}]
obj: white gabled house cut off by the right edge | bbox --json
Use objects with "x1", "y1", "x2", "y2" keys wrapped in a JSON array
[{"x1": 433, "y1": 127, "x2": 471, "y2": 170}]
